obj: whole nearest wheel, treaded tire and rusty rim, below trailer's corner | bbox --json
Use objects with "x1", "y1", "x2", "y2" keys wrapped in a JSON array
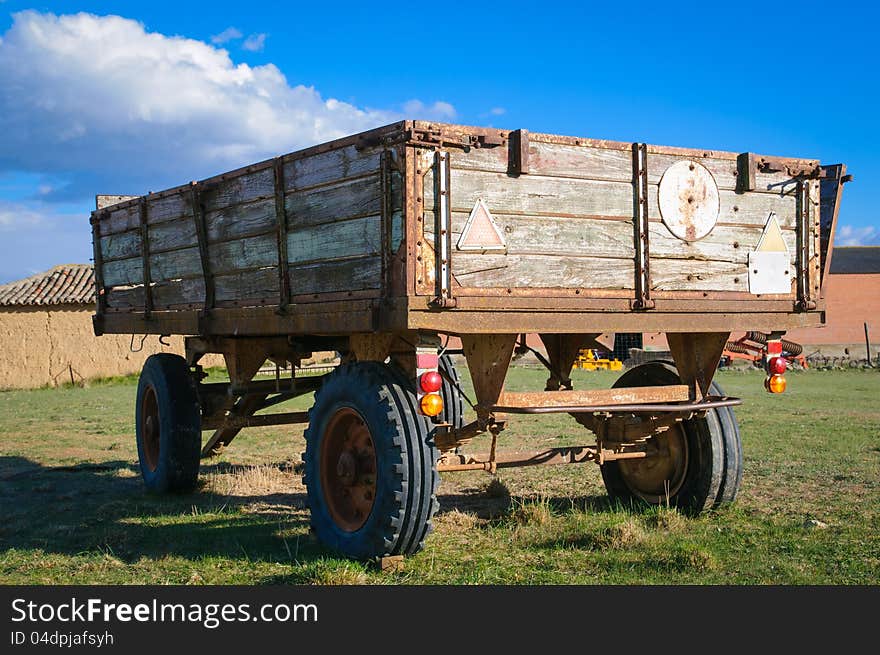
[{"x1": 303, "y1": 362, "x2": 440, "y2": 559}]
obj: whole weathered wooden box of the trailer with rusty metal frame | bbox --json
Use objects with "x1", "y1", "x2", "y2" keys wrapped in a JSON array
[{"x1": 91, "y1": 121, "x2": 845, "y2": 336}]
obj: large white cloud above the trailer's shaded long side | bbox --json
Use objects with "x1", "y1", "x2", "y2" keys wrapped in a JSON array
[{"x1": 0, "y1": 11, "x2": 404, "y2": 199}]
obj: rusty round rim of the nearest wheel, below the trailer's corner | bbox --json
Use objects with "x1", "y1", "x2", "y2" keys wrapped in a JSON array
[{"x1": 320, "y1": 407, "x2": 376, "y2": 532}]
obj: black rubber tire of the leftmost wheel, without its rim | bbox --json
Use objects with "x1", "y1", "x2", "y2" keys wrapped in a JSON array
[{"x1": 135, "y1": 353, "x2": 202, "y2": 493}]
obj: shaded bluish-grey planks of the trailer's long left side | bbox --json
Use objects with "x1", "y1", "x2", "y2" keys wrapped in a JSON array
[{"x1": 99, "y1": 140, "x2": 392, "y2": 311}]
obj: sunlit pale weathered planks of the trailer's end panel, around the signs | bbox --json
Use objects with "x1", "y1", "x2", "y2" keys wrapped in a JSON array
[{"x1": 446, "y1": 141, "x2": 797, "y2": 292}]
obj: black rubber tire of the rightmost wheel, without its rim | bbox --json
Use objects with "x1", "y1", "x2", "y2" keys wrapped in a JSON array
[{"x1": 601, "y1": 361, "x2": 742, "y2": 514}]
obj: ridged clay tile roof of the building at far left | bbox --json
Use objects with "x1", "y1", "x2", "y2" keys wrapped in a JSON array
[{"x1": 0, "y1": 264, "x2": 95, "y2": 306}]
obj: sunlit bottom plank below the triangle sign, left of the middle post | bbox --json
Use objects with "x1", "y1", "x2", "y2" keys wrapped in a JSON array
[{"x1": 452, "y1": 252, "x2": 635, "y2": 289}]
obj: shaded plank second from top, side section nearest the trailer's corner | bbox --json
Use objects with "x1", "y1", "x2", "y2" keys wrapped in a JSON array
[{"x1": 285, "y1": 171, "x2": 382, "y2": 231}]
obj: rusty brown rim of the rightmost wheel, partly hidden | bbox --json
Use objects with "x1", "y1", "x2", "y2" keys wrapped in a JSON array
[{"x1": 619, "y1": 424, "x2": 688, "y2": 505}]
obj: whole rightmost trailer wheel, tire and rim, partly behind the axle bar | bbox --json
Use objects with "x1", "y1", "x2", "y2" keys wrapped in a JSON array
[{"x1": 601, "y1": 361, "x2": 742, "y2": 513}]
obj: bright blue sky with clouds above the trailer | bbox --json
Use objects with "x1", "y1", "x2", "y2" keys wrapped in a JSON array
[{"x1": 0, "y1": 0, "x2": 880, "y2": 283}]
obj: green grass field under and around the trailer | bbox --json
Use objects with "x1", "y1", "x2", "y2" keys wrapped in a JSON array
[{"x1": 0, "y1": 368, "x2": 880, "y2": 584}]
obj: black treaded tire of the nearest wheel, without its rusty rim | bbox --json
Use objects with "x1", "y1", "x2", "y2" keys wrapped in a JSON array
[{"x1": 303, "y1": 362, "x2": 440, "y2": 559}]
